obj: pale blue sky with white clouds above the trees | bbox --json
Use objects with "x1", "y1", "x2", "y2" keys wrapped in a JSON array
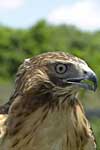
[{"x1": 0, "y1": 0, "x2": 100, "y2": 31}]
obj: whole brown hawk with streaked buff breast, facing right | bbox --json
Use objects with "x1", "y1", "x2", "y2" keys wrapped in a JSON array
[{"x1": 0, "y1": 52, "x2": 97, "y2": 150}]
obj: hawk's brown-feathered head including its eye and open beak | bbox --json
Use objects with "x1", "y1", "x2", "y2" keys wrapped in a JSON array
[{"x1": 16, "y1": 52, "x2": 97, "y2": 101}]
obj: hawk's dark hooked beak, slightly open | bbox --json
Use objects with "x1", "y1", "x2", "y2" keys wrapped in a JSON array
[{"x1": 64, "y1": 72, "x2": 97, "y2": 91}]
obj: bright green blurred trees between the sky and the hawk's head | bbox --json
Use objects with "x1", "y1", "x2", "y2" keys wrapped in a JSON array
[{"x1": 0, "y1": 20, "x2": 100, "y2": 84}]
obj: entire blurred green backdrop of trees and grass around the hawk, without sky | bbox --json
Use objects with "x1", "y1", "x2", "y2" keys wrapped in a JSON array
[{"x1": 0, "y1": 20, "x2": 100, "y2": 150}]
